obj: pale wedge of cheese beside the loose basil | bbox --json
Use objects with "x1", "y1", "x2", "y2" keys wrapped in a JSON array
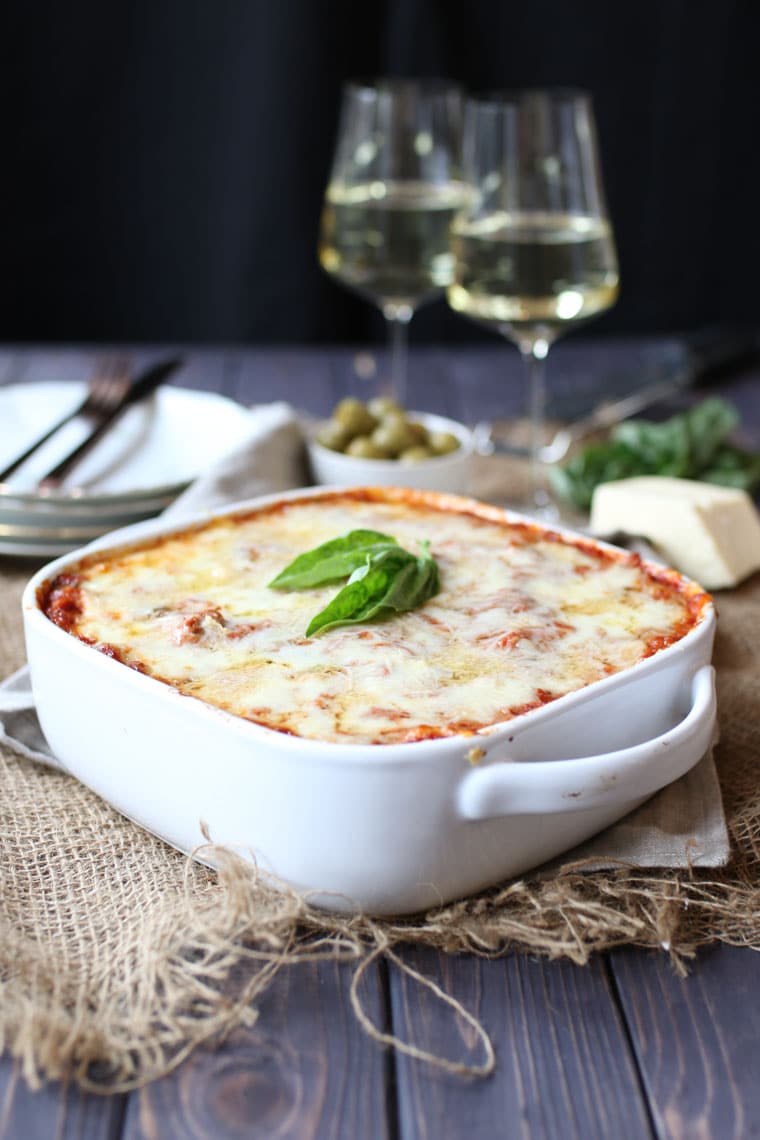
[{"x1": 590, "y1": 475, "x2": 760, "y2": 589}]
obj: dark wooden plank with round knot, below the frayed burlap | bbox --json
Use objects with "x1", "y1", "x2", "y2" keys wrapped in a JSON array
[{"x1": 123, "y1": 962, "x2": 393, "y2": 1140}]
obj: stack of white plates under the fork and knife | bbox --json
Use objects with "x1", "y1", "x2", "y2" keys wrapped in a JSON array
[{"x1": 0, "y1": 381, "x2": 251, "y2": 557}]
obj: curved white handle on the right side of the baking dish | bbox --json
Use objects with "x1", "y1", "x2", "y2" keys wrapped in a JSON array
[{"x1": 457, "y1": 665, "x2": 716, "y2": 820}]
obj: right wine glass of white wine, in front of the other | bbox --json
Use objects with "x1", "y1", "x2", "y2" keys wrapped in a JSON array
[{"x1": 448, "y1": 89, "x2": 619, "y2": 518}]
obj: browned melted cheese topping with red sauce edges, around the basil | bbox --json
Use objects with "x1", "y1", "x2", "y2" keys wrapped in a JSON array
[{"x1": 42, "y1": 490, "x2": 705, "y2": 743}]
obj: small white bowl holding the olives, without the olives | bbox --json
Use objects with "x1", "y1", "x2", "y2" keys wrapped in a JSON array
[{"x1": 307, "y1": 412, "x2": 475, "y2": 494}]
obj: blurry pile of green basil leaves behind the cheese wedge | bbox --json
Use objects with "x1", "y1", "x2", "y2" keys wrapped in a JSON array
[{"x1": 549, "y1": 398, "x2": 760, "y2": 511}]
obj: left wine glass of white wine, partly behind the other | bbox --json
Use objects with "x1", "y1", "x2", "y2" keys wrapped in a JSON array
[{"x1": 319, "y1": 79, "x2": 465, "y2": 405}]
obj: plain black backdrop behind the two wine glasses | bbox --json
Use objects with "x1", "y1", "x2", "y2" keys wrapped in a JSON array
[{"x1": 0, "y1": 0, "x2": 760, "y2": 343}]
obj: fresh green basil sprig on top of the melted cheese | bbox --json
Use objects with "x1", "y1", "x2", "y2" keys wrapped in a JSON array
[{"x1": 269, "y1": 530, "x2": 441, "y2": 637}]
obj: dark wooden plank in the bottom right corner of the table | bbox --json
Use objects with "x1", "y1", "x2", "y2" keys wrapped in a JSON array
[{"x1": 611, "y1": 946, "x2": 760, "y2": 1140}]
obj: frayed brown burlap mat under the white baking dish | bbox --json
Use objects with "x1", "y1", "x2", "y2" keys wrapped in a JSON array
[{"x1": 0, "y1": 449, "x2": 760, "y2": 1091}]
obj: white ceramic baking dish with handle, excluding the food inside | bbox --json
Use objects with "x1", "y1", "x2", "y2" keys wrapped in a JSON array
[{"x1": 23, "y1": 488, "x2": 716, "y2": 914}]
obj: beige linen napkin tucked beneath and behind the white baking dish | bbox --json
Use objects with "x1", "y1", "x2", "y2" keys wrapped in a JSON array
[{"x1": 0, "y1": 402, "x2": 729, "y2": 873}]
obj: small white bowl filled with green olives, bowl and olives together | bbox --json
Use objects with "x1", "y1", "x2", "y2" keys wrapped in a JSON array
[{"x1": 308, "y1": 398, "x2": 473, "y2": 491}]
